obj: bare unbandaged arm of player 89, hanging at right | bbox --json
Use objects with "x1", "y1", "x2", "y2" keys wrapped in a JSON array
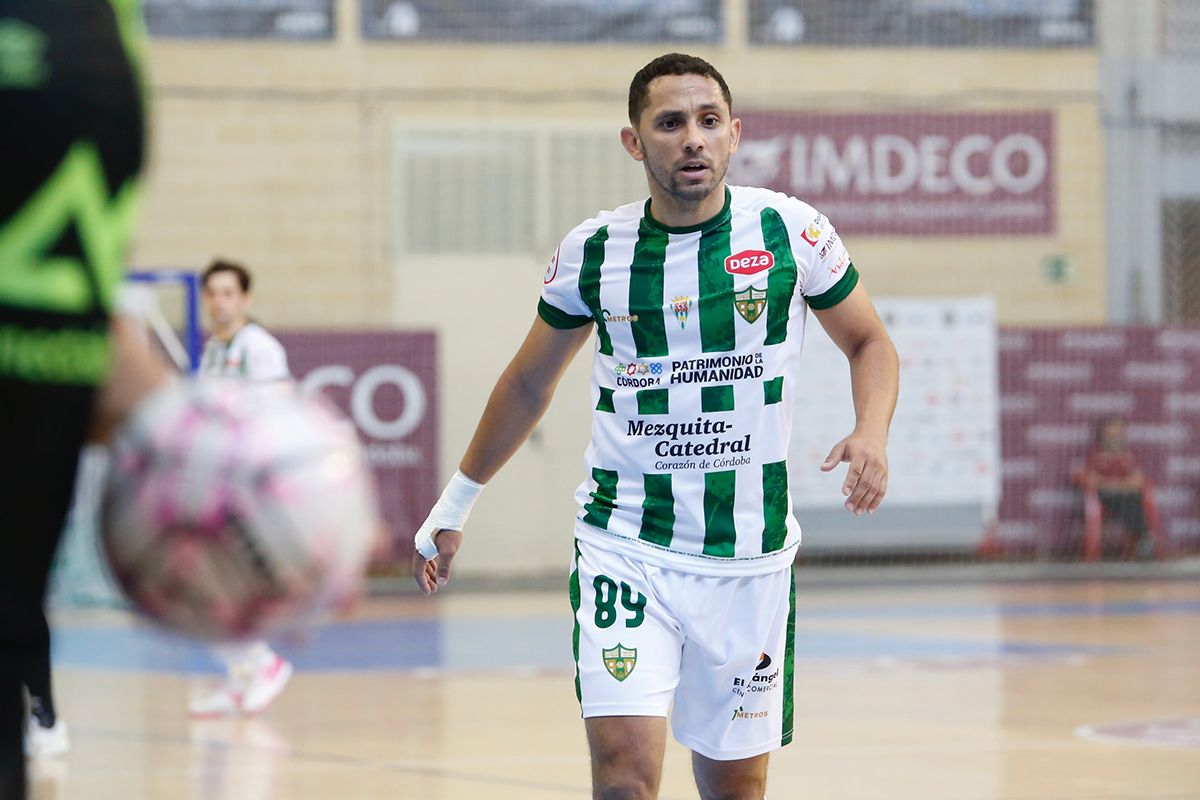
[{"x1": 812, "y1": 283, "x2": 900, "y2": 515}]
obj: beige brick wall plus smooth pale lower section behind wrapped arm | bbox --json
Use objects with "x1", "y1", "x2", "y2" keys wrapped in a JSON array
[{"x1": 134, "y1": 0, "x2": 1104, "y2": 575}]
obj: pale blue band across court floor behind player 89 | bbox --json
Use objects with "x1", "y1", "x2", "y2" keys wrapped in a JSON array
[{"x1": 54, "y1": 614, "x2": 1135, "y2": 674}]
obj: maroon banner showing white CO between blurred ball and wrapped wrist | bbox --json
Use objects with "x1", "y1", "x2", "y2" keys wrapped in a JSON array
[{"x1": 278, "y1": 331, "x2": 438, "y2": 563}]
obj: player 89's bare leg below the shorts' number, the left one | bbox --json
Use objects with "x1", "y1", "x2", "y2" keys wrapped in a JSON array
[{"x1": 584, "y1": 717, "x2": 667, "y2": 800}]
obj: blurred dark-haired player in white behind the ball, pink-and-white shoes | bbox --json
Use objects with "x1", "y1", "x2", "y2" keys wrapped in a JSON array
[{"x1": 188, "y1": 259, "x2": 292, "y2": 717}]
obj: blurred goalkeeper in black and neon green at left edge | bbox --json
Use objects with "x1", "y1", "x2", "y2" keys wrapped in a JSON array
[{"x1": 0, "y1": 0, "x2": 166, "y2": 800}]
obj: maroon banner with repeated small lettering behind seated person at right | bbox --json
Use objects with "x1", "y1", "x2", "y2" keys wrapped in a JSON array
[{"x1": 997, "y1": 327, "x2": 1200, "y2": 553}]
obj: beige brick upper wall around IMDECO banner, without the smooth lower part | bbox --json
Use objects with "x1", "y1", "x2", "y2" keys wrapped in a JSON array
[{"x1": 136, "y1": 17, "x2": 1104, "y2": 325}]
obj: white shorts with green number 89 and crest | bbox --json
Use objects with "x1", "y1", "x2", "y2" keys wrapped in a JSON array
[{"x1": 570, "y1": 540, "x2": 796, "y2": 760}]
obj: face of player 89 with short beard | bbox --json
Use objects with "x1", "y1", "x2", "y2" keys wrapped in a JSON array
[{"x1": 637, "y1": 76, "x2": 740, "y2": 204}]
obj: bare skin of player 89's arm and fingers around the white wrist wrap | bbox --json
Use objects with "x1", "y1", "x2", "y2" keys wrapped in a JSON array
[{"x1": 413, "y1": 317, "x2": 592, "y2": 595}]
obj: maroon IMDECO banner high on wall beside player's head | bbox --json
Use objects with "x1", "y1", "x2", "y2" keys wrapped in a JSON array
[{"x1": 730, "y1": 110, "x2": 1055, "y2": 236}]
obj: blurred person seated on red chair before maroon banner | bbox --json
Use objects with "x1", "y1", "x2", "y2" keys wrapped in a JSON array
[{"x1": 1079, "y1": 417, "x2": 1154, "y2": 558}]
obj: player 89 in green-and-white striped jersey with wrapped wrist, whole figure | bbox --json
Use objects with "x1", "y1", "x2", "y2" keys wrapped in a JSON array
[{"x1": 414, "y1": 54, "x2": 899, "y2": 799}]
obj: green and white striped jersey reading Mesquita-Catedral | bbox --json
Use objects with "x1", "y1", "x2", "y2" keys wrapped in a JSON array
[{"x1": 538, "y1": 187, "x2": 858, "y2": 575}]
